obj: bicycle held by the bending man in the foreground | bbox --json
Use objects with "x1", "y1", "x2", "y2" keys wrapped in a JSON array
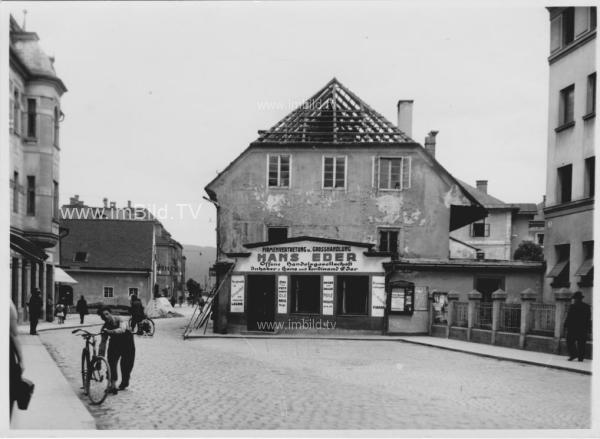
[{"x1": 71, "y1": 329, "x2": 111, "y2": 405}]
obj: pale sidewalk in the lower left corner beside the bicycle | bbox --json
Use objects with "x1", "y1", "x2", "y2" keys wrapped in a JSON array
[{"x1": 10, "y1": 336, "x2": 96, "y2": 430}]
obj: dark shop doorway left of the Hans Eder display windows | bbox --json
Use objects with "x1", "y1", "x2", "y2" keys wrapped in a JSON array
[{"x1": 246, "y1": 275, "x2": 275, "y2": 332}]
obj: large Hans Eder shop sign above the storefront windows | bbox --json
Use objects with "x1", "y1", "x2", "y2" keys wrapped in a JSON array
[{"x1": 236, "y1": 241, "x2": 389, "y2": 273}]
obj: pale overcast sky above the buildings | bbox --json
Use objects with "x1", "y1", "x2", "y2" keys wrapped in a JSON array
[{"x1": 0, "y1": 2, "x2": 549, "y2": 245}]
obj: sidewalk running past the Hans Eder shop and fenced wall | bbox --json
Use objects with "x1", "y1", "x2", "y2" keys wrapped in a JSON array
[{"x1": 187, "y1": 328, "x2": 592, "y2": 375}]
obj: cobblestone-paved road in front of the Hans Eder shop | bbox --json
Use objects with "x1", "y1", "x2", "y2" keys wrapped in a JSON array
[{"x1": 41, "y1": 318, "x2": 591, "y2": 429}]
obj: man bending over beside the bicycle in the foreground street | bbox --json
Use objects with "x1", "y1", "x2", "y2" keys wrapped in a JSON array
[{"x1": 98, "y1": 306, "x2": 135, "y2": 394}]
